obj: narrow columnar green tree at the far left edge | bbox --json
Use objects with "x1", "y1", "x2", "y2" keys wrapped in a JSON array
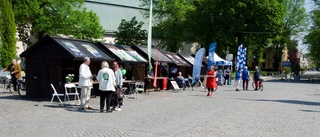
[{"x1": 0, "y1": 0, "x2": 16, "y2": 67}]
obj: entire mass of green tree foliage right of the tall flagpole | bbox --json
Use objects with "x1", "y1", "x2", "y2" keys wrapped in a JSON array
[{"x1": 141, "y1": 0, "x2": 306, "y2": 70}]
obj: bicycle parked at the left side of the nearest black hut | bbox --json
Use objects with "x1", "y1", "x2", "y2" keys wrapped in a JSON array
[{"x1": 6, "y1": 77, "x2": 27, "y2": 98}]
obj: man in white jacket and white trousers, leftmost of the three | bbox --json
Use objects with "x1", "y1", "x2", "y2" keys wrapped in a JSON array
[{"x1": 79, "y1": 57, "x2": 93, "y2": 111}]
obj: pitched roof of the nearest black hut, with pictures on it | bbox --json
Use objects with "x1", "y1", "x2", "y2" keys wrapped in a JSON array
[{"x1": 20, "y1": 35, "x2": 114, "y2": 61}]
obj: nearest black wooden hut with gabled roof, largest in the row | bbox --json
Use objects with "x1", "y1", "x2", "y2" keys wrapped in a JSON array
[{"x1": 20, "y1": 35, "x2": 114, "y2": 99}]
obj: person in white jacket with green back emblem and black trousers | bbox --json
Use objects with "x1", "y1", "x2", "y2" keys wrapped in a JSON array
[{"x1": 97, "y1": 61, "x2": 116, "y2": 113}]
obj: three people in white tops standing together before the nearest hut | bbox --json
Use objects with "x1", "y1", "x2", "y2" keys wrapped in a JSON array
[{"x1": 79, "y1": 57, "x2": 123, "y2": 113}]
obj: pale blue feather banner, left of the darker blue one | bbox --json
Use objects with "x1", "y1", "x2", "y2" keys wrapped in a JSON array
[{"x1": 192, "y1": 48, "x2": 205, "y2": 84}]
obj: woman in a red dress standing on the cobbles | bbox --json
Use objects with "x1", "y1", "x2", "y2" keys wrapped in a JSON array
[{"x1": 206, "y1": 66, "x2": 217, "y2": 97}]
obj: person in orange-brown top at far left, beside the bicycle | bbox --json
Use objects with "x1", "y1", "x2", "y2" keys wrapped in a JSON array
[{"x1": 2, "y1": 59, "x2": 22, "y2": 91}]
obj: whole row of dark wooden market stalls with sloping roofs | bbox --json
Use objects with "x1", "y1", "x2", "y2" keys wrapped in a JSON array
[{"x1": 20, "y1": 35, "x2": 200, "y2": 99}]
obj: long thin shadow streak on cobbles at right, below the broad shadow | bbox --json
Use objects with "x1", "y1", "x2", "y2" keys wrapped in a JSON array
[{"x1": 244, "y1": 99, "x2": 320, "y2": 106}]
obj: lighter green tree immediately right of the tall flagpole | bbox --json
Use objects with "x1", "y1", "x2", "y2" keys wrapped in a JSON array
[{"x1": 142, "y1": 0, "x2": 194, "y2": 52}]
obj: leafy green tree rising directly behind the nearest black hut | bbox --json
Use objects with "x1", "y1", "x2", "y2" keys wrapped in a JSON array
[{"x1": 13, "y1": 0, "x2": 104, "y2": 45}]
